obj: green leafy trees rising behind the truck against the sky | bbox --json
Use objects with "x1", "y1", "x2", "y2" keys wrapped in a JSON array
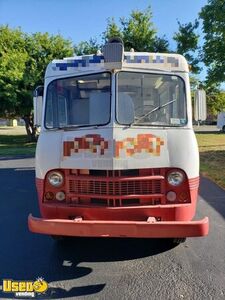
[{"x1": 0, "y1": 0, "x2": 225, "y2": 135}]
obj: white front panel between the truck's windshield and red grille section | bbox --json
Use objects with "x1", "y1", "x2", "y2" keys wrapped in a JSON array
[{"x1": 36, "y1": 127, "x2": 199, "y2": 178}]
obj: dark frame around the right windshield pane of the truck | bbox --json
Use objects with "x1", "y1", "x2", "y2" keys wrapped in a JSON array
[{"x1": 115, "y1": 70, "x2": 188, "y2": 128}]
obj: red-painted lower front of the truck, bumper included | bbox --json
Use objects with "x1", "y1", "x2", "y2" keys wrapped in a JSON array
[{"x1": 29, "y1": 169, "x2": 209, "y2": 237}]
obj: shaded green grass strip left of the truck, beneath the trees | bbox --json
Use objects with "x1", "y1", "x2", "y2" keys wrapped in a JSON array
[{"x1": 0, "y1": 128, "x2": 36, "y2": 157}]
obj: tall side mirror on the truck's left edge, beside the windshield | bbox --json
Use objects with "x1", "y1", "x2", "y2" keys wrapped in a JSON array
[{"x1": 33, "y1": 86, "x2": 44, "y2": 127}]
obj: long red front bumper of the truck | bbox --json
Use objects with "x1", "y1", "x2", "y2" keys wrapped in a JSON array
[{"x1": 28, "y1": 214, "x2": 209, "y2": 238}]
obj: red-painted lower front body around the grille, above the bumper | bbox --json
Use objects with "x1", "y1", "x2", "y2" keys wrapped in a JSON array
[{"x1": 36, "y1": 173, "x2": 202, "y2": 221}]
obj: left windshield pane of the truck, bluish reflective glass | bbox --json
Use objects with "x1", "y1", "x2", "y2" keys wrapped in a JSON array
[{"x1": 45, "y1": 72, "x2": 111, "y2": 129}]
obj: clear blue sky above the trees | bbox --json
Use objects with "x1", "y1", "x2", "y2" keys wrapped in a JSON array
[{"x1": 0, "y1": 0, "x2": 207, "y2": 79}]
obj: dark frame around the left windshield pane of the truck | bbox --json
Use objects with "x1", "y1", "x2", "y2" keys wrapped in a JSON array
[{"x1": 44, "y1": 70, "x2": 112, "y2": 130}]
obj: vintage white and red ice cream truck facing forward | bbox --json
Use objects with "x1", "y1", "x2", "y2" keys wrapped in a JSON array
[{"x1": 28, "y1": 39, "x2": 209, "y2": 243}]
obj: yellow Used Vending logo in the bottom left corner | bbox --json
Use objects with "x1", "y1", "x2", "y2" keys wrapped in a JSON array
[{"x1": 2, "y1": 277, "x2": 48, "y2": 298}]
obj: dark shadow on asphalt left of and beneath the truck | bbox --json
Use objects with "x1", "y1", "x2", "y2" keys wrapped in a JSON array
[{"x1": 0, "y1": 168, "x2": 172, "y2": 299}]
